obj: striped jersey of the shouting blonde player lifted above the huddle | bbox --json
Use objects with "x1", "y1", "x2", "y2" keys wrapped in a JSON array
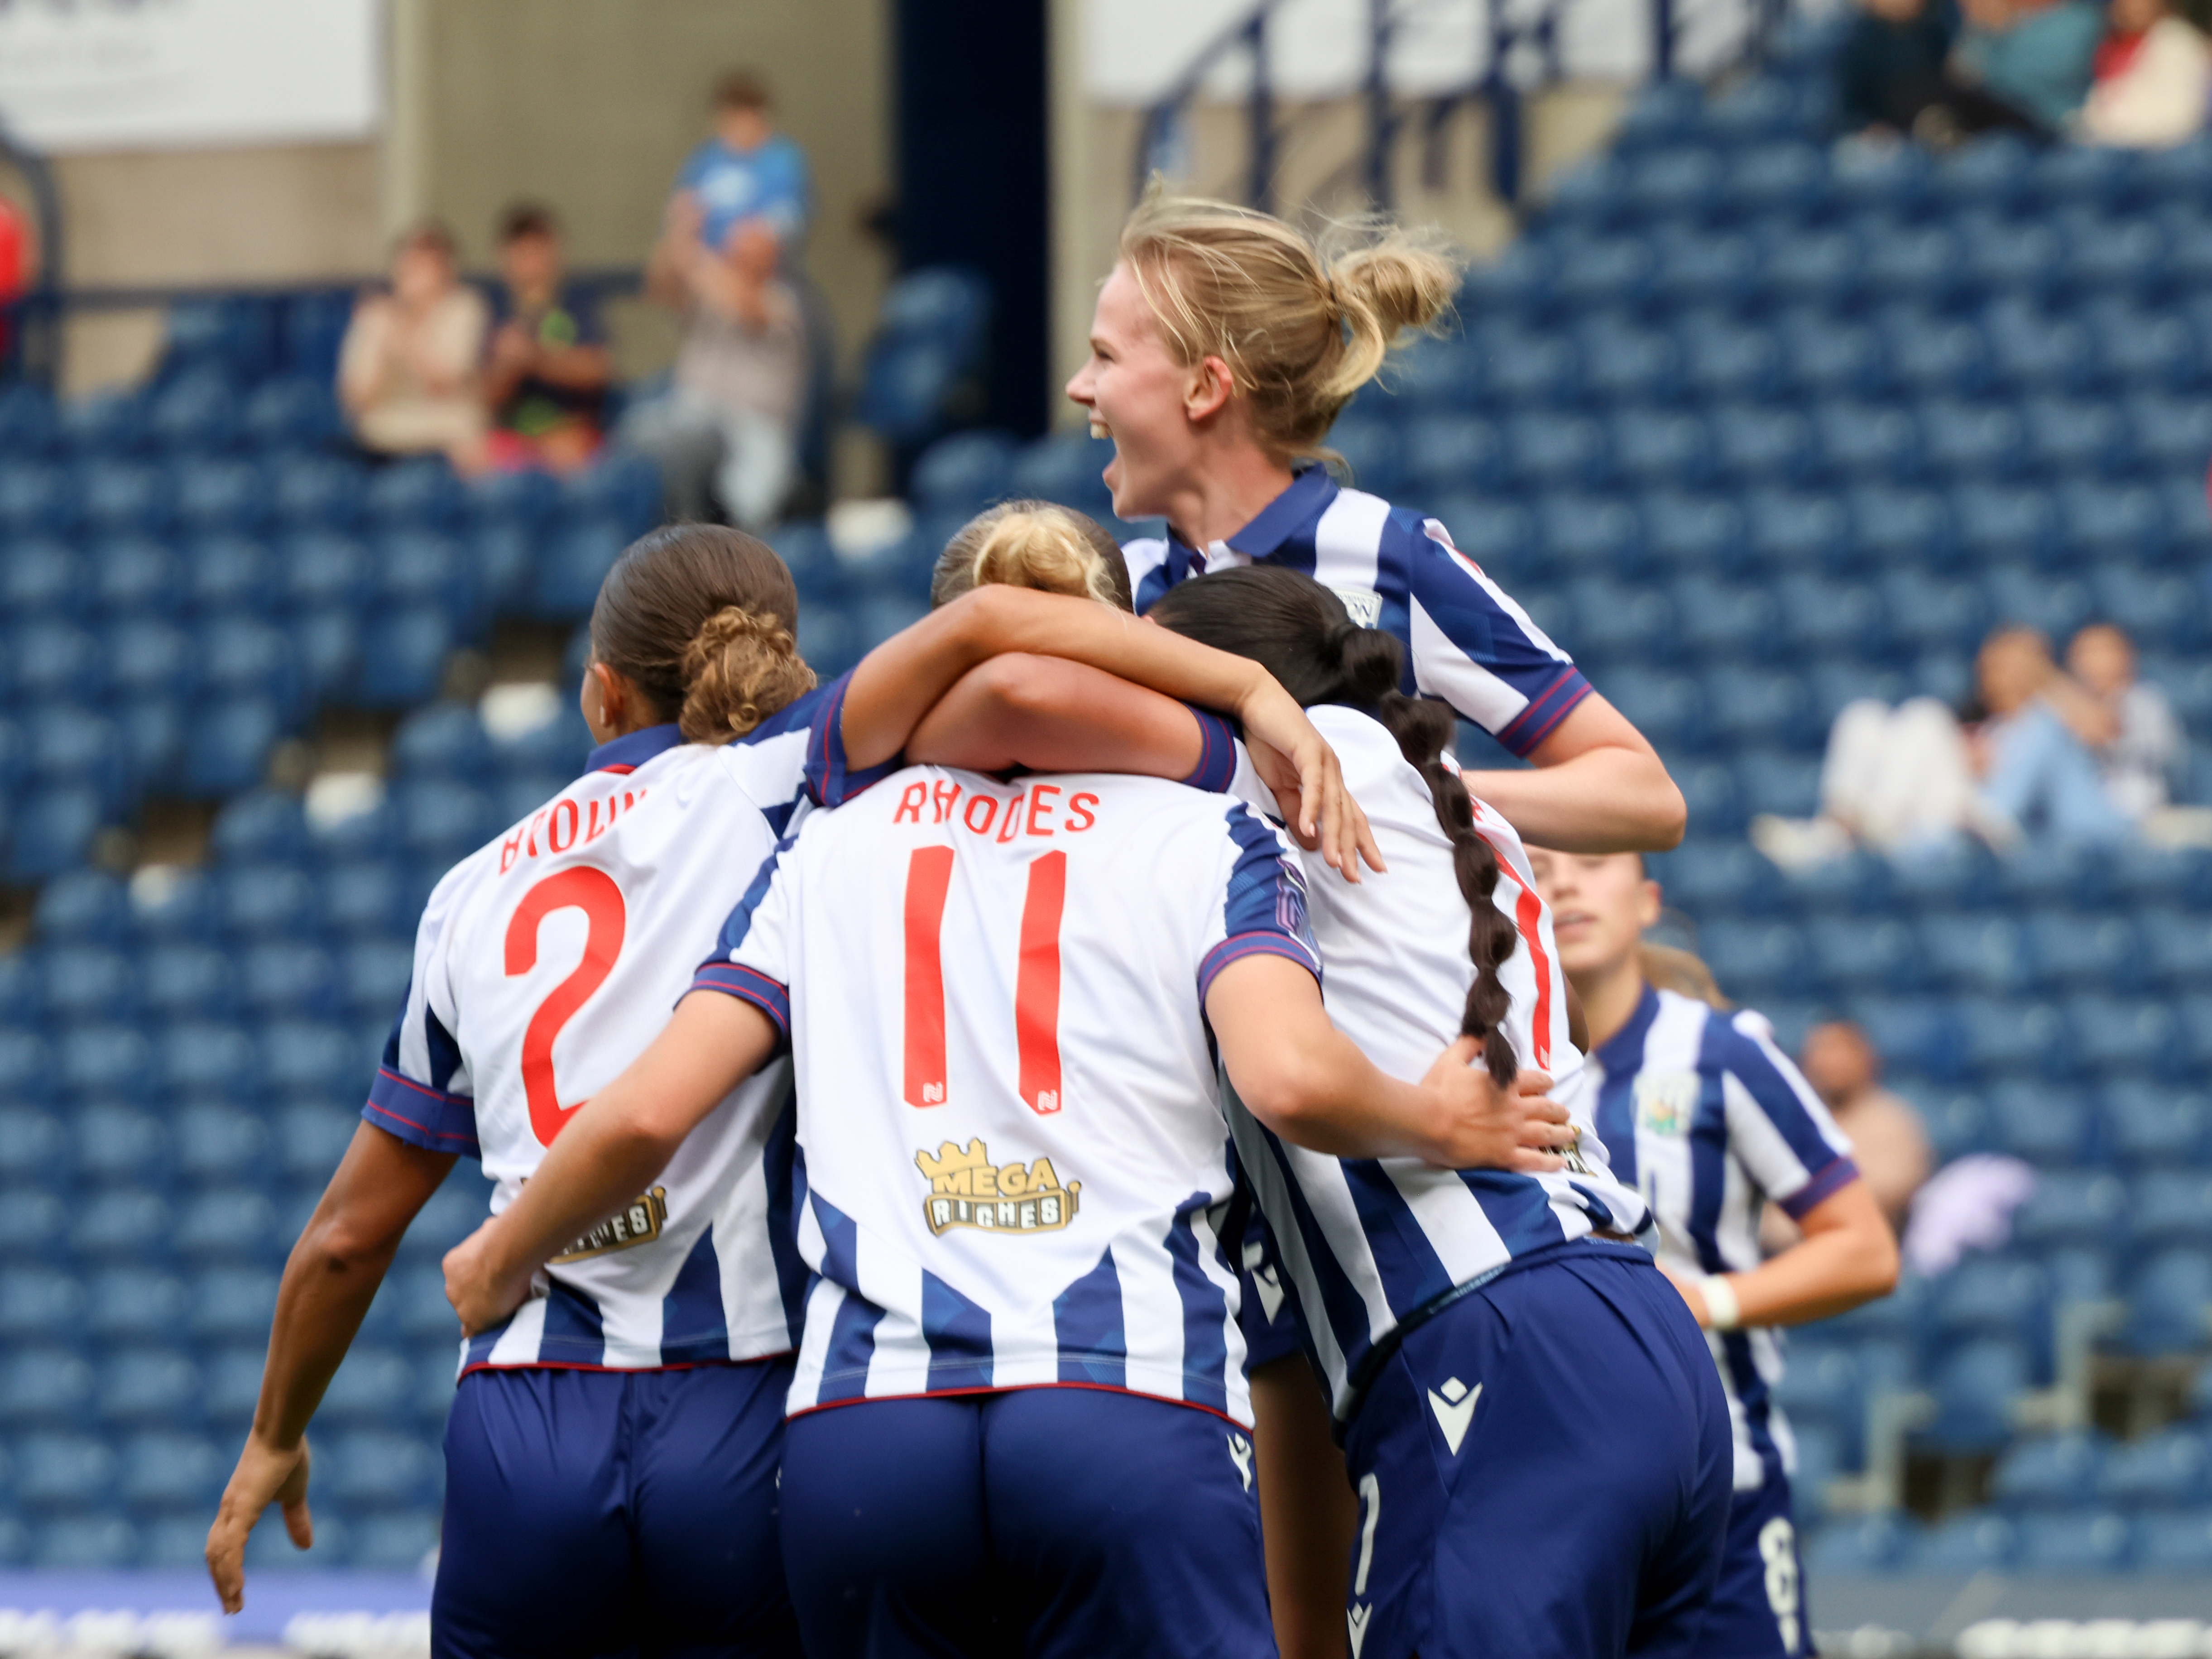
[{"x1": 1122, "y1": 467, "x2": 1590, "y2": 757}]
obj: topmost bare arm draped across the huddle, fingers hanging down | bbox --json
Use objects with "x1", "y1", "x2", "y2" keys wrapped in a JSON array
[{"x1": 843, "y1": 586, "x2": 1382, "y2": 880}]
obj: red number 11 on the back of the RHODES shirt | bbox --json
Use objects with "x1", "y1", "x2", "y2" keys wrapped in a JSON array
[{"x1": 905, "y1": 847, "x2": 1068, "y2": 1115}]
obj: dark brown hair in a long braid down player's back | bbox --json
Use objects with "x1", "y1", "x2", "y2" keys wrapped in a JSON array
[{"x1": 1146, "y1": 564, "x2": 1520, "y2": 1088}]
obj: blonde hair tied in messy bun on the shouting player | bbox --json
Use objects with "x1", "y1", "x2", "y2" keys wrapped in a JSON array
[{"x1": 1119, "y1": 179, "x2": 1464, "y2": 460}]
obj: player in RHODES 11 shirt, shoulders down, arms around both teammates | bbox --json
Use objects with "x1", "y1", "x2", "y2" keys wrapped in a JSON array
[{"x1": 447, "y1": 761, "x2": 1570, "y2": 1657}]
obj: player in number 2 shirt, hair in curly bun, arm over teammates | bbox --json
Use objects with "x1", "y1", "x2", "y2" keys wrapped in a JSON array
[{"x1": 208, "y1": 513, "x2": 1360, "y2": 1654}]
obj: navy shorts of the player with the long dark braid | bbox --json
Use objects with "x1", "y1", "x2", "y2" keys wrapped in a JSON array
[{"x1": 1345, "y1": 1241, "x2": 1734, "y2": 1659}]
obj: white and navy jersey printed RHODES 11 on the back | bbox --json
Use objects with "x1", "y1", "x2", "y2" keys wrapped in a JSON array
[{"x1": 697, "y1": 765, "x2": 1320, "y2": 1424}]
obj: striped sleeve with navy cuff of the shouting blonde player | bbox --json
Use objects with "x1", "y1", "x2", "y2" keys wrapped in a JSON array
[{"x1": 1382, "y1": 511, "x2": 1590, "y2": 757}]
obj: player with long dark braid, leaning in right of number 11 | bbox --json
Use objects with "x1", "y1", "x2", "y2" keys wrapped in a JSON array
[{"x1": 1150, "y1": 564, "x2": 1727, "y2": 1659}]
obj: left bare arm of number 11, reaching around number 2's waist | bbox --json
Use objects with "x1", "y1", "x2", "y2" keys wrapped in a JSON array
[{"x1": 445, "y1": 991, "x2": 781, "y2": 1336}]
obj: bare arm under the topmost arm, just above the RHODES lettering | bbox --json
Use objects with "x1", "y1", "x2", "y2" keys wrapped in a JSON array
[{"x1": 907, "y1": 652, "x2": 1205, "y2": 779}]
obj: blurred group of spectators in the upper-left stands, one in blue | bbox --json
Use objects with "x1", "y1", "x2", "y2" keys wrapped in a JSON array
[{"x1": 338, "y1": 71, "x2": 810, "y2": 529}]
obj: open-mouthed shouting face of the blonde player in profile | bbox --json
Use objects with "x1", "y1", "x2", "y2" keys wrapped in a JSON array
[{"x1": 1068, "y1": 265, "x2": 1212, "y2": 518}]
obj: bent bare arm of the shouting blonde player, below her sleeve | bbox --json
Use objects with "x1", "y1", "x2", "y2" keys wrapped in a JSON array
[{"x1": 1467, "y1": 692, "x2": 1688, "y2": 852}]
